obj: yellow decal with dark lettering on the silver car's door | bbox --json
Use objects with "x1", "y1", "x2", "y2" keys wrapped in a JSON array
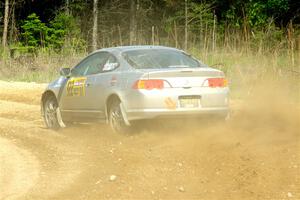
[{"x1": 67, "y1": 77, "x2": 86, "y2": 97}]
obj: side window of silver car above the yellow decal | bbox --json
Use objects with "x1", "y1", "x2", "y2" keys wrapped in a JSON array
[{"x1": 72, "y1": 52, "x2": 109, "y2": 76}]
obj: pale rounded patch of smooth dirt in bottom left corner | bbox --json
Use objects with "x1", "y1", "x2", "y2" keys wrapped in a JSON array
[{"x1": 0, "y1": 137, "x2": 40, "y2": 200}]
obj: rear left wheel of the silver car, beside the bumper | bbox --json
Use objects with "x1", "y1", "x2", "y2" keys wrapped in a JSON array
[{"x1": 108, "y1": 99, "x2": 129, "y2": 134}]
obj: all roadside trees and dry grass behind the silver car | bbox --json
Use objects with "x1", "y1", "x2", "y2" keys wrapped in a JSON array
[{"x1": 0, "y1": 0, "x2": 300, "y2": 97}]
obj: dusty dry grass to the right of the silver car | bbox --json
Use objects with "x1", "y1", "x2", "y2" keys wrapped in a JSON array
[{"x1": 192, "y1": 49, "x2": 300, "y2": 100}]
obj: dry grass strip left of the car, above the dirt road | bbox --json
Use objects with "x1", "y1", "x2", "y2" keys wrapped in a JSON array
[{"x1": 0, "y1": 48, "x2": 86, "y2": 83}]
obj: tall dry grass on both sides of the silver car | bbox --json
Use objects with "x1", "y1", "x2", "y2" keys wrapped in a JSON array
[{"x1": 0, "y1": 45, "x2": 300, "y2": 99}]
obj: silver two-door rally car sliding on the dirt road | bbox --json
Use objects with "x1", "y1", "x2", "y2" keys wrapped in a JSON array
[{"x1": 41, "y1": 46, "x2": 229, "y2": 132}]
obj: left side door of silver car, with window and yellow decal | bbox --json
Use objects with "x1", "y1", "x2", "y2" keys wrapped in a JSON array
[{"x1": 60, "y1": 52, "x2": 108, "y2": 116}]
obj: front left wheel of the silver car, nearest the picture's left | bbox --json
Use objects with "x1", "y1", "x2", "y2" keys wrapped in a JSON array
[{"x1": 44, "y1": 96, "x2": 60, "y2": 130}]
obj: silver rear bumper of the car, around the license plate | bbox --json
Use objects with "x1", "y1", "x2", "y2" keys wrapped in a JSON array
[{"x1": 123, "y1": 87, "x2": 229, "y2": 121}]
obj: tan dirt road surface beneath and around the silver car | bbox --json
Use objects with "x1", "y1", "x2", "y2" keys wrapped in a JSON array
[{"x1": 0, "y1": 81, "x2": 300, "y2": 200}]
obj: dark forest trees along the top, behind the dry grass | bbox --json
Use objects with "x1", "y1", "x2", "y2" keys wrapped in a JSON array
[{"x1": 0, "y1": 0, "x2": 300, "y2": 50}]
